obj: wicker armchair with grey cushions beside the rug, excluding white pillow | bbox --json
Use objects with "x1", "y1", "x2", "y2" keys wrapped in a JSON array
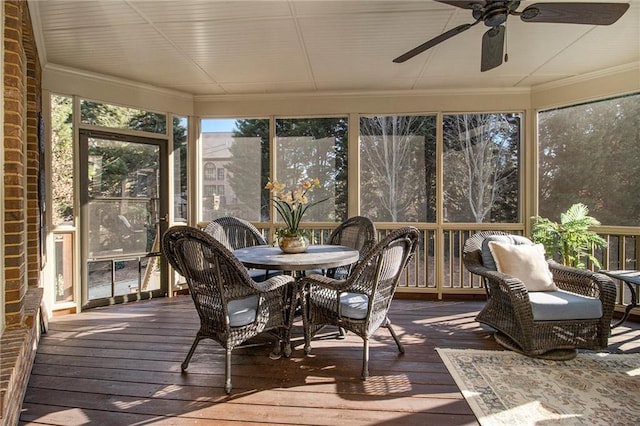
[{"x1": 463, "y1": 231, "x2": 616, "y2": 359}]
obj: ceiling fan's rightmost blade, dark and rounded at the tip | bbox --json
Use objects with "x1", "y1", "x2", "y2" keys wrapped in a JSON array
[{"x1": 520, "y1": 3, "x2": 629, "y2": 25}]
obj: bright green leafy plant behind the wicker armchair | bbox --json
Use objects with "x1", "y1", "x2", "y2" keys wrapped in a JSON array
[{"x1": 531, "y1": 203, "x2": 607, "y2": 268}]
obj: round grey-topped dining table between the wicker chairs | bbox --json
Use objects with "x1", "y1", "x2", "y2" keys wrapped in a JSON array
[{"x1": 233, "y1": 244, "x2": 360, "y2": 357}]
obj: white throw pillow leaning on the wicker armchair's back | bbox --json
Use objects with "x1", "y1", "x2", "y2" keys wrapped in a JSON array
[{"x1": 489, "y1": 241, "x2": 558, "y2": 291}]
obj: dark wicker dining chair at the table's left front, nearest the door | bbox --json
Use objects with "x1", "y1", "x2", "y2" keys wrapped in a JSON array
[{"x1": 162, "y1": 226, "x2": 294, "y2": 393}]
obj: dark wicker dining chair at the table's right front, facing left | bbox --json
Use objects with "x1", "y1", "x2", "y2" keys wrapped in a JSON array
[{"x1": 300, "y1": 227, "x2": 420, "y2": 380}]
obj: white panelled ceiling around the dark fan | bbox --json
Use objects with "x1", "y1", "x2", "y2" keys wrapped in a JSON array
[{"x1": 29, "y1": 0, "x2": 640, "y2": 95}]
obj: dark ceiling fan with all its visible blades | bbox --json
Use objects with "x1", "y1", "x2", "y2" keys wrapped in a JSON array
[{"x1": 393, "y1": 0, "x2": 629, "y2": 71}]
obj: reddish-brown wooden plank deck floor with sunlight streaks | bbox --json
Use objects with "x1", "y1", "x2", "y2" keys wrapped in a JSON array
[{"x1": 20, "y1": 296, "x2": 640, "y2": 426}]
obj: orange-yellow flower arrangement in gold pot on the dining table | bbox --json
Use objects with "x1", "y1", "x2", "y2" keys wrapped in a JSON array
[{"x1": 265, "y1": 178, "x2": 326, "y2": 238}]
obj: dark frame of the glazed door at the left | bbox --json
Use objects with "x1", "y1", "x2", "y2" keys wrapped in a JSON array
[{"x1": 79, "y1": 129, "x2": 169, "y2": 309}]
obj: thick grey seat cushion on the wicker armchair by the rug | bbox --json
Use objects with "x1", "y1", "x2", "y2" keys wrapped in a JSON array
[{"x1": 529, "y1": 290, "x2": 602, "y2": 321}]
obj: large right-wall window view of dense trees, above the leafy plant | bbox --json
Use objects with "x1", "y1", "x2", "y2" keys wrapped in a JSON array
[{"x1": 538, "y1": 93, "x2": 640, "y2": 226}]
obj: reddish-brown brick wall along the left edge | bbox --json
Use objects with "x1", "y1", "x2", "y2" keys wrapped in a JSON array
[{"x1": 0, "y1": 0, "x2": 42, "y2": 425}]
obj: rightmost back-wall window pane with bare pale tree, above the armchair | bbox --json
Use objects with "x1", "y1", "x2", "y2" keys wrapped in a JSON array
[{"x1": 443, "y1": 113, "x2": 521, "y2": 223}]
